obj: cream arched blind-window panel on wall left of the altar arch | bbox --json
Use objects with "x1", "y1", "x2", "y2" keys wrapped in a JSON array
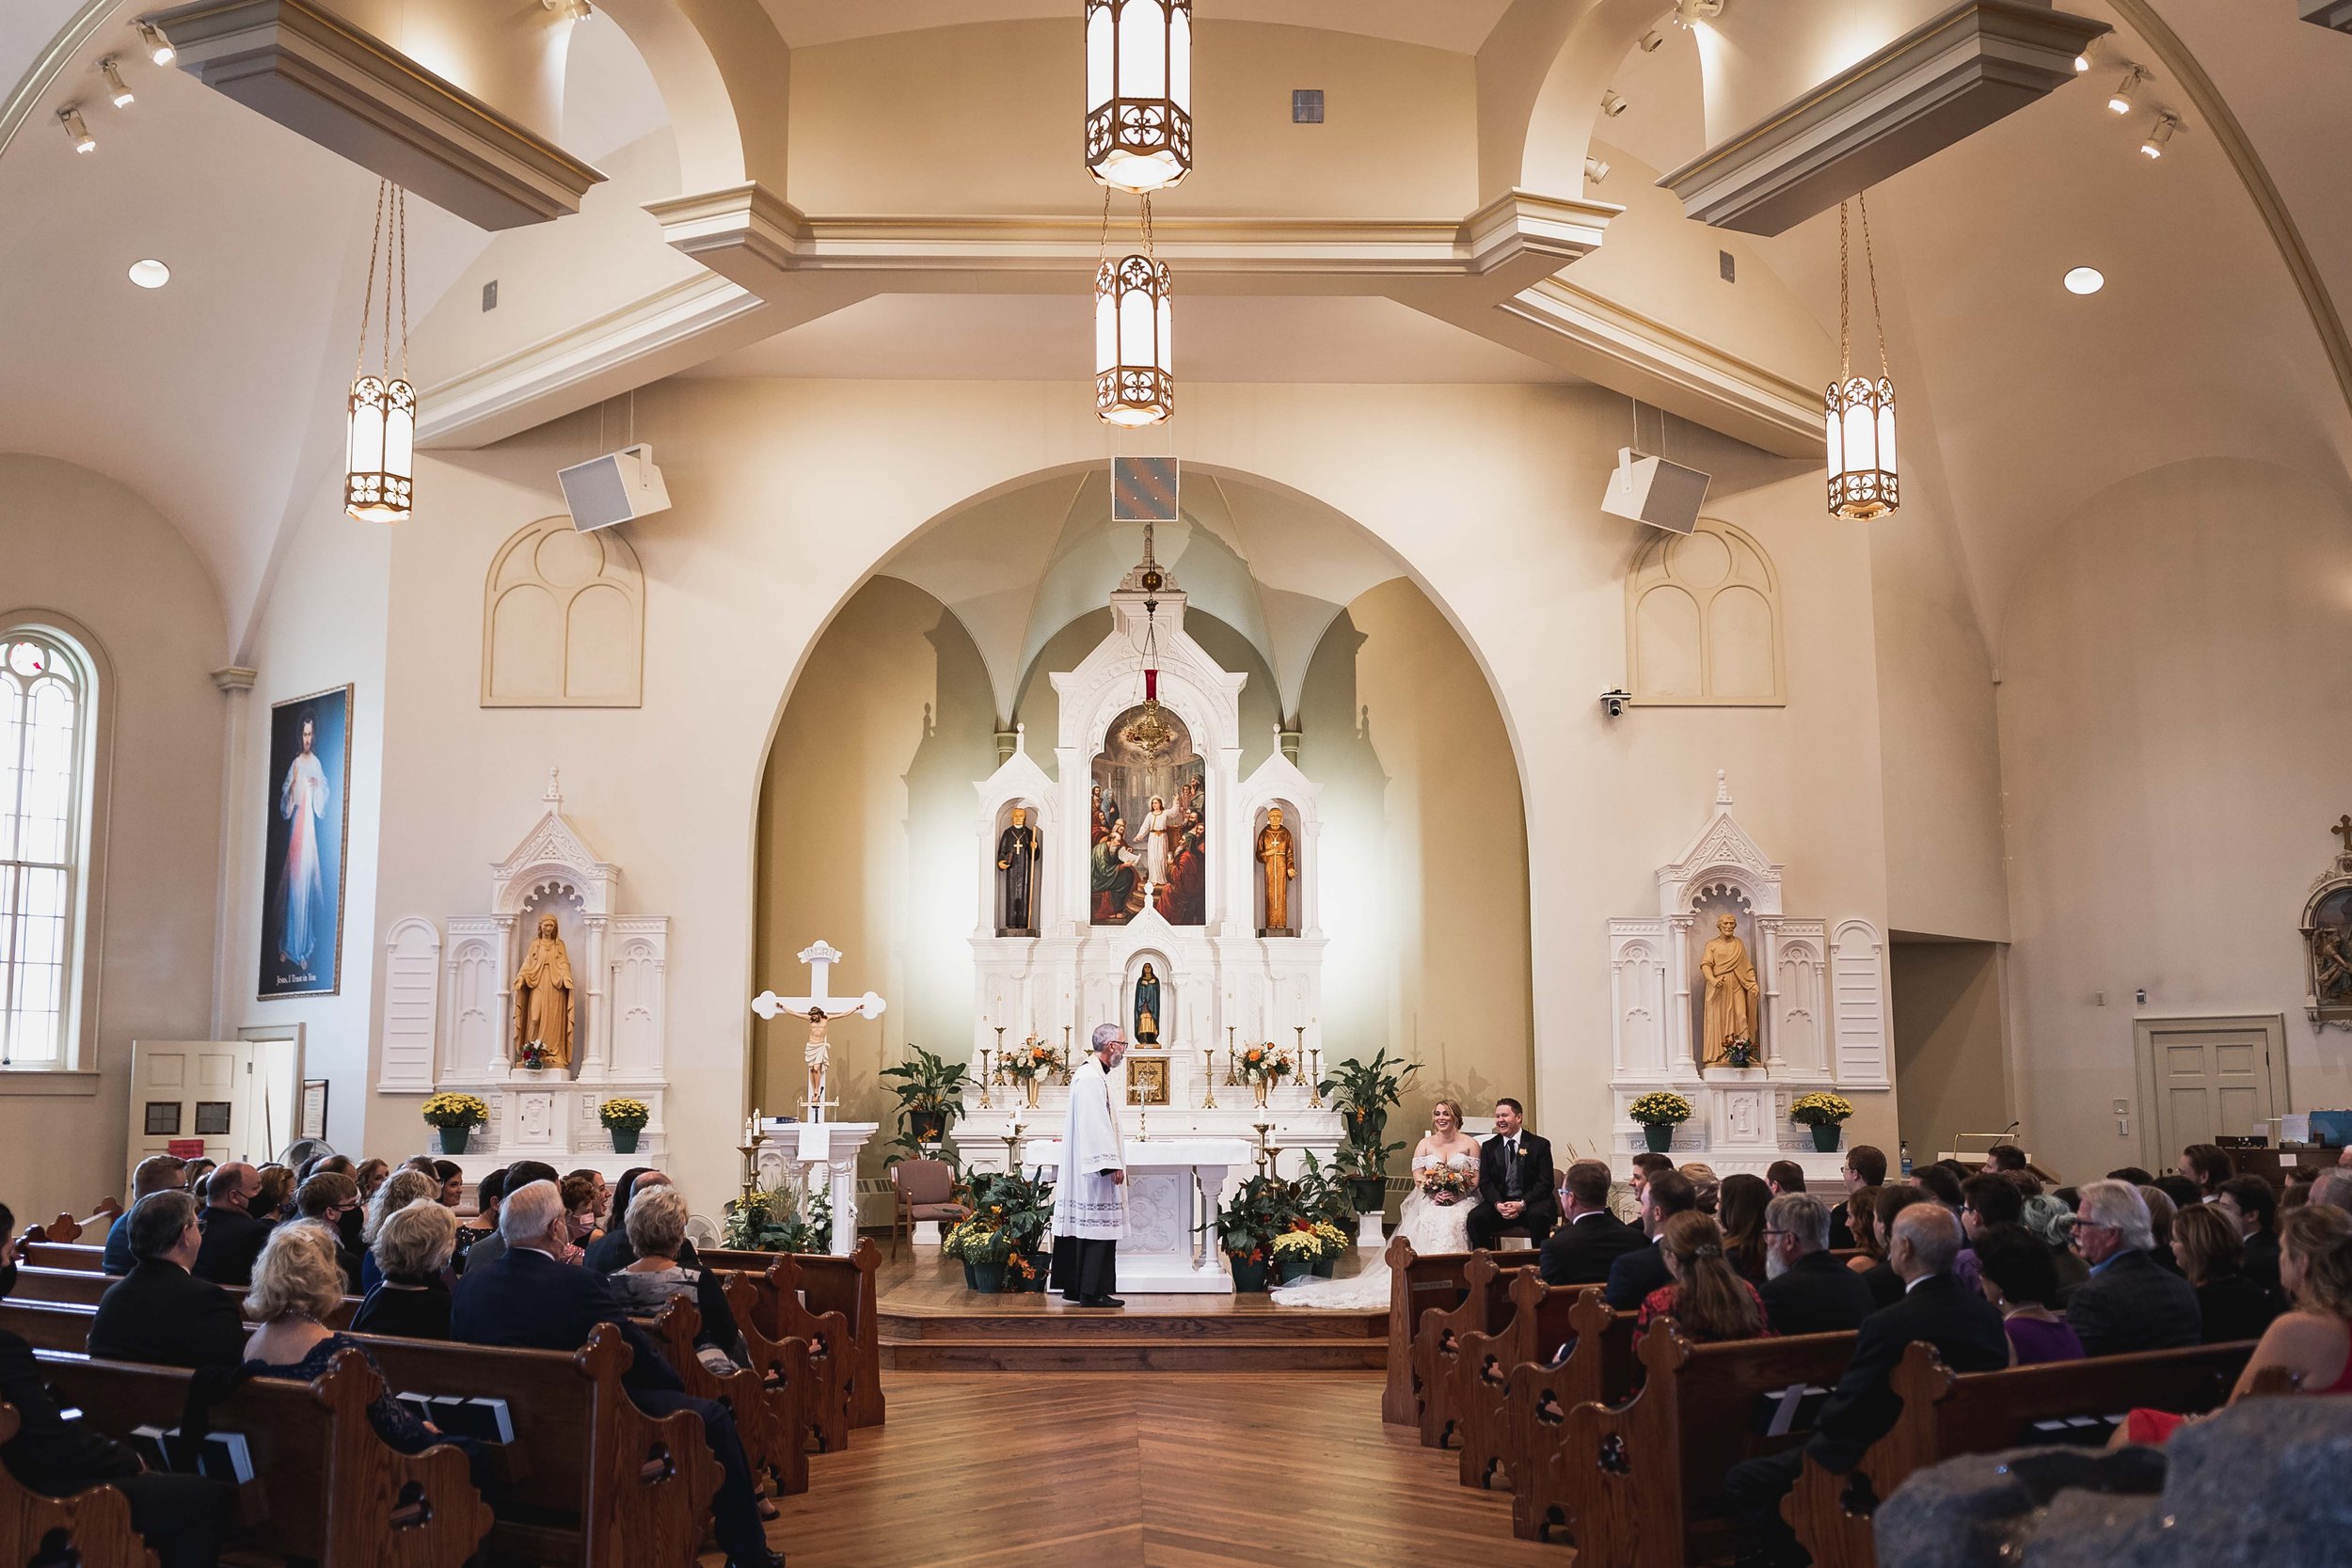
[{"x1": 483, "y1": 517, "x2": 644, "y2": 707}]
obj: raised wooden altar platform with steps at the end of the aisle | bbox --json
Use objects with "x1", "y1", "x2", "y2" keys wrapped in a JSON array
[{"x1": 875, "y1": 1248, "x2": 1388, "y2": 1373}]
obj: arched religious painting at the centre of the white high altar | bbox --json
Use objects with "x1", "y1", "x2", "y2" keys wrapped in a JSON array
[{"x1": 1087, "y1": 703, "x2": 1209, "y2": 927}]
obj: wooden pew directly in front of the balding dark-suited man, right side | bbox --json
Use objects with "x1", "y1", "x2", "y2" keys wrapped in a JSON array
[{"x1": 1536, "y1": 1319, "x2": 1853, "y2": 1568}]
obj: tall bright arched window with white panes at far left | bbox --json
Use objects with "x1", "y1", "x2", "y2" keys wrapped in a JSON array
[{"x1": 0, "y1": 627, "x2": 97, "y2": 1068}]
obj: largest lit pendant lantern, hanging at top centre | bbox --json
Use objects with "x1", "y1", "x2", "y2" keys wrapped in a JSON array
[{"x1": 1087, "y1": 0, "x2": 1193, "y2": 195}]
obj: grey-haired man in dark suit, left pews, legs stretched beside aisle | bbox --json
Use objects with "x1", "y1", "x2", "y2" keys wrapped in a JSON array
[{"x1": 450, "y1": 1180, "x2": 784, "y2": 1568}]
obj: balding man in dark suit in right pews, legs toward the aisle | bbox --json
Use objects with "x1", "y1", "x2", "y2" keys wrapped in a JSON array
[{"x1": 1724, "y1": 1204, "x2": 2009, "y2": 1568}]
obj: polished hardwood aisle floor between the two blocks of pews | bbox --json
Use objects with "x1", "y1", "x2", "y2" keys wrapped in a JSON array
[{"x1": 743, "y1": 1373, "x2": 1574, "y2": 1568}]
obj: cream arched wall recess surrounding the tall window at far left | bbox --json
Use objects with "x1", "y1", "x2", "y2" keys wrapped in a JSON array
[{"x1": 0, "y1": 453, "x2": 229, "y2": 1225}]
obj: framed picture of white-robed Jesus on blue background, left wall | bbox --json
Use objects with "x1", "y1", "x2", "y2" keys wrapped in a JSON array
[{"x1": 259, "y1": 687, "x2": 353, "y2": 1002}]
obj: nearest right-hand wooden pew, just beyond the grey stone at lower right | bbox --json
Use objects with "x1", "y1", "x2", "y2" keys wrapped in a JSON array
[{"x1": 1781, "y1": 1340, "x2": 2253, "y2": 1568}]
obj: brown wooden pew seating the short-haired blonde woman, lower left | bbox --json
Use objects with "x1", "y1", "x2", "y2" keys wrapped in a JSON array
[{"x1": 40, "y1": 1352, "x2": 492, "y2": 1568}]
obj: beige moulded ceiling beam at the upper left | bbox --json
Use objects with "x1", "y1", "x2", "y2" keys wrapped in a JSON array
[{"x1": 146, "y1": 0, "x2": 605, "y2": 230}]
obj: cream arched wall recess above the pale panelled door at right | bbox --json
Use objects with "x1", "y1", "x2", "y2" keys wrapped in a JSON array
[{"x1": 1999, "y1": 458, "x2": 2352, "y2": 1176}]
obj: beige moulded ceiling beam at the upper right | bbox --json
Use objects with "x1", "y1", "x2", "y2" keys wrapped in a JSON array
[{"x1": 1659, "y1": 0, "x2": 2112, "y2": 235}]
